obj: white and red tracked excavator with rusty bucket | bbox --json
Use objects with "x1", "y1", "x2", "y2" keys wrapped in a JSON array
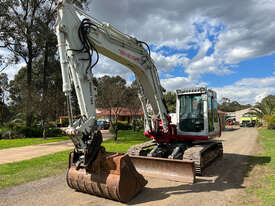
[{"x1": 55, "y1": 0, "x2": 223, "y2": 202}]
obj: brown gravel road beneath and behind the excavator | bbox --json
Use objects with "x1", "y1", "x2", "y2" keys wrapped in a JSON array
[{"x1": 0, "y1": 128, "x2": 257, "y2": 206}]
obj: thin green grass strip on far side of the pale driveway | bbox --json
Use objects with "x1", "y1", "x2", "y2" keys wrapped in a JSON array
[{"x1": 0, "y1": 136, "x2": 69, "y2": 149}]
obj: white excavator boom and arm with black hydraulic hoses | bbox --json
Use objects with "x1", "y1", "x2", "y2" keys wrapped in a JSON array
[{"x1": 56, "y1": 0, "x2": 169, "y2": 165}]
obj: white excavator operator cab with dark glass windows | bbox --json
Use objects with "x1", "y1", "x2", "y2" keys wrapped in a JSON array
[{"x1": 176, "y1": 87, "x2": 220, "y2": 140}]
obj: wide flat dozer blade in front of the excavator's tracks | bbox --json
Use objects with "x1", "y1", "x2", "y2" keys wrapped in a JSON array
[{"x1": 130, "y1": 156, "x2": 195, "y2": 183}]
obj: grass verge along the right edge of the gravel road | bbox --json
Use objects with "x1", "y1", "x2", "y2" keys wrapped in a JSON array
[{"x1": 244, "y1": 128, "x2": 275, "y2": 206}]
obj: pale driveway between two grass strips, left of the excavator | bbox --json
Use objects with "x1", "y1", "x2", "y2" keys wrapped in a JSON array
[{"x1": 0, "y1": 130, "x2": 113, "y2": 165}]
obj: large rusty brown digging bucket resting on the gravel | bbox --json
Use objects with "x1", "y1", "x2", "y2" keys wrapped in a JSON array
[{"x1": 67, "y1": 147, "x2": 147, "y2": 202}]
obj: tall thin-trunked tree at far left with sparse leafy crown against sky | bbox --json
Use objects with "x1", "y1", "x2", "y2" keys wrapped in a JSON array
[{"x1": 0, "y1": 0, "x2": 46, "y2": 126}]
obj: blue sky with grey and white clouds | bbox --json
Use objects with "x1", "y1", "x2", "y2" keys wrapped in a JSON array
[{"x1": 0, "y1": 0, "x2": 275, "y2": 104}]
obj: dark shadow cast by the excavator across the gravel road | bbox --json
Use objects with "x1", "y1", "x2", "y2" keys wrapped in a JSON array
[{"x1": 128, "y1": 153, "x2": 271, "y2": 205}]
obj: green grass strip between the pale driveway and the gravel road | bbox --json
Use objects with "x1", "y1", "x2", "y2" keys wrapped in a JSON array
[{"x1": 0, "y1": 131, "x2": 149, "y2": 189}]
